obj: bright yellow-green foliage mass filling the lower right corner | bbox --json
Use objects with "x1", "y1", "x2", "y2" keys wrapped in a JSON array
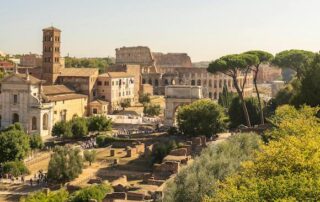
[{"x1": 206, "y1": 106, "x2": 320, "y2": 202}]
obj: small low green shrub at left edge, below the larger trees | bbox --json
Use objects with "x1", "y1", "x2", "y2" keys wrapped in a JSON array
[{"x1": 2, "y1": 161, "x2": 30, "y2": 177}]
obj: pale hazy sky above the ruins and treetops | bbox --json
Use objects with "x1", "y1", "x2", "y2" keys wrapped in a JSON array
[{"x1": 0, "y1": 0, "x2": 320, "y2": 61}]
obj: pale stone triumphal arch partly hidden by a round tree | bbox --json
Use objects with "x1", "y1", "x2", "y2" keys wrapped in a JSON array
[{"x1": 164, "y1": 85, "x2": 203, "y2": 126}]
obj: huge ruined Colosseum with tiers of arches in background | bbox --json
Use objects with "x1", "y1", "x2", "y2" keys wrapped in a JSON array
[{"x1": 112, "y1": 46, "x2": 253, "y2": 100}]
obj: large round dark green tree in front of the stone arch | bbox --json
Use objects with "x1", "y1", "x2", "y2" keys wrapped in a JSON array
[{"x1": 177, "y1": 99, "x2": 226, "y2": 137}]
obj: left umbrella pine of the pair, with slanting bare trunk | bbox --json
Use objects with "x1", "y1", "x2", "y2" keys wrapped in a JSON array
[{"x1": 208, "y1": 54, "x2": 259, "y2": 127}]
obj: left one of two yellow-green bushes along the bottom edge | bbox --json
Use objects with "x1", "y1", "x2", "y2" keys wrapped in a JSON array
[{"x1": 20, "y1": 189, "x2": 69, "y2": 202}]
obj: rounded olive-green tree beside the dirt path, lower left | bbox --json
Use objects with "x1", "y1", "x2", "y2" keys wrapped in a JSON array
[{"x1": 48, "y1": 147, "x2": 83, "y2": 183}]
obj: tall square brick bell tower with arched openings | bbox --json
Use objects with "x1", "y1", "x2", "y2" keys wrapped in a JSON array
[{"x1": 41, "y1": 27, "x2": 62, "y2": 85}]
